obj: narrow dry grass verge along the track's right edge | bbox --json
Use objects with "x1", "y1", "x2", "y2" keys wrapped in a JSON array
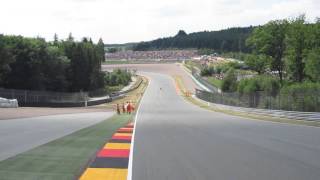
[{"x1": 173, "y1": 76, "x2": 320, "y2": 127}]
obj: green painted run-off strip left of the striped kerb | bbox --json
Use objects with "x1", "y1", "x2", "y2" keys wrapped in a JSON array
[{"x1": 0, "y1": 115, "x2": 132, "y2": 180}]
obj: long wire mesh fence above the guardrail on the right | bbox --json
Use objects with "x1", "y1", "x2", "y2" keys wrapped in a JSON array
[{"x1": 196, "y1": 89, "x2": 320, "y2": 112}]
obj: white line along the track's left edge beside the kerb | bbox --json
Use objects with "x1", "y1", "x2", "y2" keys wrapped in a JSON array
[{"x1": 127, "y1": 78, "x2": 151, "y2": 180}]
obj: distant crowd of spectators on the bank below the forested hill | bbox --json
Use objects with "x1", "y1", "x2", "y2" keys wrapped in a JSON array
[{"x1": 106, "y1": 50, "x2": 197, "y2": 60}]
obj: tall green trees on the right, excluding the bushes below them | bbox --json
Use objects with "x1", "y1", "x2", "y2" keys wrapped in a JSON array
[{"x1": 245, "y1": 15, "x2": 320, "y2": 84}]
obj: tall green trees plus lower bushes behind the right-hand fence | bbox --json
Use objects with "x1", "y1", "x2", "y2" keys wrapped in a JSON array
[{"x1": 212, "y1": 15, "x2": 320, "y2": 111}]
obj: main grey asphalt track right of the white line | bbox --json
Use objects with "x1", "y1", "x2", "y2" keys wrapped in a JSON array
[{"x1": 132, "y1": 73, "x2": 320, "y2": 180}]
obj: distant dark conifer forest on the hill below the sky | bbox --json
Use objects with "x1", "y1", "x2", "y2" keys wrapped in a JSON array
[{"x1": 134, "y1": 27, "x2": 254, "y2": 52}]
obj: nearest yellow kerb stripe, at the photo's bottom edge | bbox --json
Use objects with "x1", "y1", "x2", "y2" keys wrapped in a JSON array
[{"x1": 80, "y1": 168, "x2": 128, "y2": 180}]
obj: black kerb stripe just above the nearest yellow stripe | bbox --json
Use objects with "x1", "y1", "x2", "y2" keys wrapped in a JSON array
[{"x1": 90, "y1": 157, "x2": 129, "y2": 169}]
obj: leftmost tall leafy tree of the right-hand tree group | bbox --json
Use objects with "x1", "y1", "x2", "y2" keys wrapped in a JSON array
[{"x1": 246, "y1": 20, "x2": 288, "y2": 83}]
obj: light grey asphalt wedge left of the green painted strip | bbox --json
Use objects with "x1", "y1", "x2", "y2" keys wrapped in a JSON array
[{"x1": 0, "y1": 112, "x2": 113, "y2": 161}]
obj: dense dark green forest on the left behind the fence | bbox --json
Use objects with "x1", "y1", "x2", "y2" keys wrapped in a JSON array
[{"x1": 0, "y1": 34, "x2": 106, "y2": 92}]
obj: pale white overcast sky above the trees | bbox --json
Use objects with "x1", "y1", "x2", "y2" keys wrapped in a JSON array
[{"x1": 0, "y1": 0, "x2": 320, "y2": 44}]
